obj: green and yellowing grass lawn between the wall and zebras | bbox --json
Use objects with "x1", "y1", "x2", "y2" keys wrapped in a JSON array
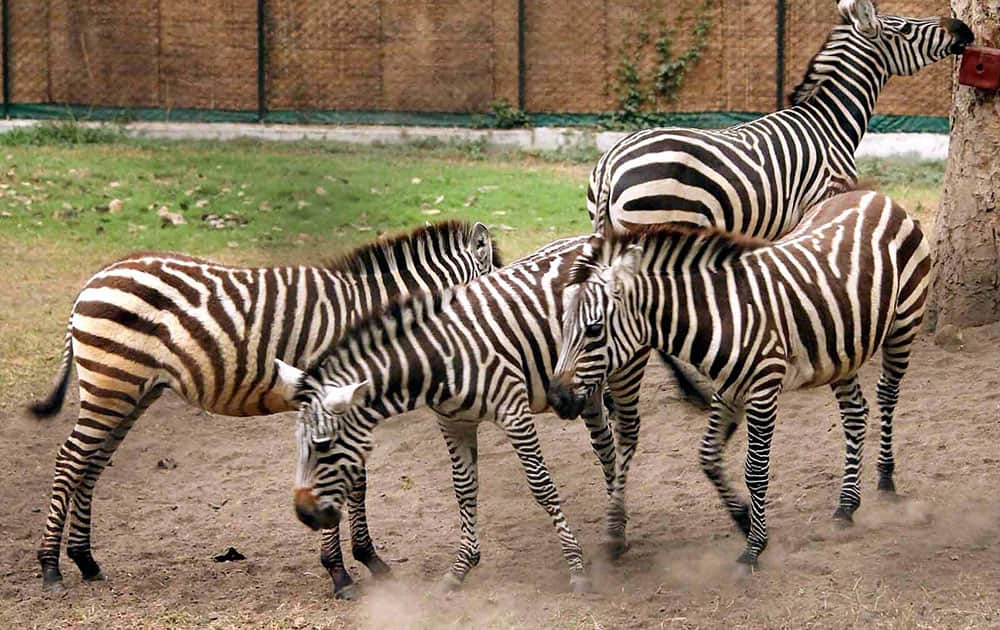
[{"x1": 0, "y1": 125, "x2": 943, "y2": 408}]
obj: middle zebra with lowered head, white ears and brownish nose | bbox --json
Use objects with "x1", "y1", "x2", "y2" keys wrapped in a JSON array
[{"x1": 279, "y1": 236, "x2": 637, "y2": 592}]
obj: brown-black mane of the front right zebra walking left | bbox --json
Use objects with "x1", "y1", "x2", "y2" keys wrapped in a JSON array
[{"x1": 567, "y1": 224, "x2": 771, "y2": 286}]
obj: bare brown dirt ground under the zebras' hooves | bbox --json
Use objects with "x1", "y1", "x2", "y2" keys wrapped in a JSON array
[{"x1": 0, "y1": 326, "x2": 1000, "y2": 629}]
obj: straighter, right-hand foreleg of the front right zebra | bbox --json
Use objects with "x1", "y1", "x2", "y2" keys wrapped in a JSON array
[{"x1": 739, "y1": 393, "x2": 778, "y2": 568}]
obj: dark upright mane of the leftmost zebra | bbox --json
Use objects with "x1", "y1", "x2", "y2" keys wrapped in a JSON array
[{"x1": 324, "y1": 221, "x2": 503, "y2": 275}]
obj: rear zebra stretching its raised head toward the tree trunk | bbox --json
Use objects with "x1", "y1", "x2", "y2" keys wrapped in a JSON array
[{"x1": 587, "y1": 0, "x2": 973, "y2": 239}]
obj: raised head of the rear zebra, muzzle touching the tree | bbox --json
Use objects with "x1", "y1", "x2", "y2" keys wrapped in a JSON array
[{"x1": 837, "y1": 0, "x2": 974, "y2": 75}]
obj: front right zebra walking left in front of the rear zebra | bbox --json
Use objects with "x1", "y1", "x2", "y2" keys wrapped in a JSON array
[{"x1": 549, "y1": 192, "x2": 931, "y2": 567}]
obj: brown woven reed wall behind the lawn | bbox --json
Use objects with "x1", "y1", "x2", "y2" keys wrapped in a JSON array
[{"x1": 0, "y1": 0, "x2": 952, "y2": 116}]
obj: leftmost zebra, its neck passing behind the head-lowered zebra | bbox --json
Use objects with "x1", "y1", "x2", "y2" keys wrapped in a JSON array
[{"x1": 31, "y1": 222, "x2": 500, "y2": 598}]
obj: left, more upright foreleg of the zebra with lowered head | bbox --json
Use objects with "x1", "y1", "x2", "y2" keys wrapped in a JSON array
[{"x1": 438, "y1": 416, "x2": 479, "y2": 590}]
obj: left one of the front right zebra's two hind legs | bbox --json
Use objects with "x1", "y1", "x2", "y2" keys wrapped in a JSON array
[{"x1": 831, "y1": 375, "x2": 868, "y2": 525}]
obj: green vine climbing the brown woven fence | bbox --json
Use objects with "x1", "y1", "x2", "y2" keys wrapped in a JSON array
[{"x1": 605, "y1": 0, "x2": 714, "y2": 129}]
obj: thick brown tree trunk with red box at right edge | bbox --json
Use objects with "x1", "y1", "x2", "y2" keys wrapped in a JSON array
[{"x1": 928, "y1": 0, "x2": 1000, "y2": 328}]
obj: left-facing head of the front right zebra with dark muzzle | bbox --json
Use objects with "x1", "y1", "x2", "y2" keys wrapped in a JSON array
[{"x1": 548, "y1": 235, "x2": 642, "y2": 418}]
